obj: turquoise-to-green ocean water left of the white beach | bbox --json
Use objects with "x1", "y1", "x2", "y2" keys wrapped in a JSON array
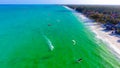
[{"x1": 0, "y1": 5, "x2": 120, "y2": 68}]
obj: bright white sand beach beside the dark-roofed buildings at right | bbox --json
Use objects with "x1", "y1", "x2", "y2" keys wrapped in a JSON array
[{"x1": 89, "y1": 24, "x2": 120, "y2": 58}]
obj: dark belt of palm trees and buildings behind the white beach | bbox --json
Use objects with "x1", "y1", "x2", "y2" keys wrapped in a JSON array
[{"x1": 69, "y1": 5, "x2": 120, "y2": 34}]
